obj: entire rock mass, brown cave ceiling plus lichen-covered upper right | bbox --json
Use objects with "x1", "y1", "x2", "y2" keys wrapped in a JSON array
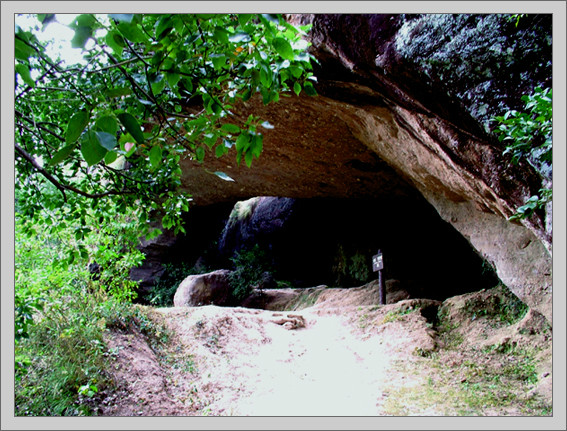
[{"x1": 172, "y1": 15, "x2": 552, "y2": 320}]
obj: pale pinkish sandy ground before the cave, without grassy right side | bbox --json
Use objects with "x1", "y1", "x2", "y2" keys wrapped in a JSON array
[{"x1": 101, "y1": 288, "x2": 551, "y2": 416}]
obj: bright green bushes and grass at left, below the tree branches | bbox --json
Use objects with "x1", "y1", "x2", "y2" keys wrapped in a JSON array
[{"x1": 14, "y1": 208, "x2": 151, "y2": 416}]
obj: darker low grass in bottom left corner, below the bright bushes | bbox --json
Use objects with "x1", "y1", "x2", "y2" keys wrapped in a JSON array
[{"x1": 15, "y1": 294, "x2": 167, "y2": 416}]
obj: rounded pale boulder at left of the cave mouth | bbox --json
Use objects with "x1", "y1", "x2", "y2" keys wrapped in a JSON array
[{"x1": 173, "y1": 269, "x2": 234, "y2": 307}]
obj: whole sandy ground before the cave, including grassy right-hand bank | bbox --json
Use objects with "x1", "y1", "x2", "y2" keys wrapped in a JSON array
[{"x1": 99, "y1": 289, "x2": 552, "y2": 416}]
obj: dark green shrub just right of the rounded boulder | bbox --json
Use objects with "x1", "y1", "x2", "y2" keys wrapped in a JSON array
[{"x1": 230, "y1": 244, "x2": 271, "y2": 301}]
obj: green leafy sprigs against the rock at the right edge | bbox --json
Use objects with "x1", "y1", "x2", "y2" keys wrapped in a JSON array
[{"x1": 494, "y1": 88, "x2": 553, "y2": 220}]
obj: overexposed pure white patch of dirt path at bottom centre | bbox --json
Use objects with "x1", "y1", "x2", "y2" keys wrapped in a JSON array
[{"x1": 200, "y1": 313, "x2": 389, "y2": 416}]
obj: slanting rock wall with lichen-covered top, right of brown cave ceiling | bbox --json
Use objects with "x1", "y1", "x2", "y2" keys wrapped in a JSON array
[{"x1": 299, "y1": 14, "x2": 552, "y2": 320}]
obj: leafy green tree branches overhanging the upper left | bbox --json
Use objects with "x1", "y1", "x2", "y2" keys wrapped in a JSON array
[{"x1": 15, "y1": 14, "x2": 316, "y2": 237}]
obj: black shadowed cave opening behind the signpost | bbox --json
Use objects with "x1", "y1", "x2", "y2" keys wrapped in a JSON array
[{"x1": 159, "y1": 197, "x2": 499, "y2": 306}]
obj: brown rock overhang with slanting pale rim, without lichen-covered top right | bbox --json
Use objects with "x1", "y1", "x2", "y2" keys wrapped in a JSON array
[{"x1": 171, "y1": 15, "x2": 552, "y2": 320}]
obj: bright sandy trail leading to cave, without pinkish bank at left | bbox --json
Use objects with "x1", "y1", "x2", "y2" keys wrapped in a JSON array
[{"x1": 158, "y1": 306, "x2": 406, "y2": 416}]
